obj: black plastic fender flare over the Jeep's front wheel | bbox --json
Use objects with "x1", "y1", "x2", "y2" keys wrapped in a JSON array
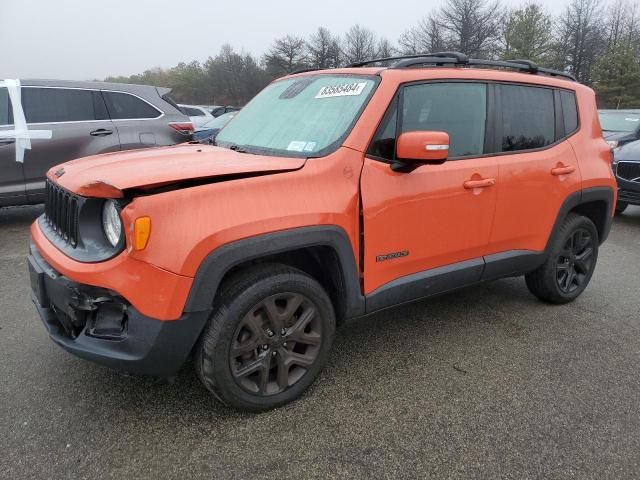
[{"x1": 184, "y1": 225, "x2": 365, "y2": 318}]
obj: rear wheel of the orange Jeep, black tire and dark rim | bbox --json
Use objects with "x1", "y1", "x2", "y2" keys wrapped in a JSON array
[{"x1": 525, "y1": 213, "x2": 600, "y2": 304}]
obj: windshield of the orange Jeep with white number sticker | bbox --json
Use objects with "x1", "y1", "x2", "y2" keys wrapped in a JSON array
[{"x1": 216, "y1": 75, "x2": 376, "y2": 157}]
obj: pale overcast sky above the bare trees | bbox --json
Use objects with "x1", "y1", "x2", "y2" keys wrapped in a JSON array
[{"x1": 0, "y1": 0, "x2": 565, "y2": 80}]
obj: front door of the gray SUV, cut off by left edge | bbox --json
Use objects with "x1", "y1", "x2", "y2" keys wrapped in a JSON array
[{"x1": 0, "y1": 87, "x2": 26, "y2": 207}]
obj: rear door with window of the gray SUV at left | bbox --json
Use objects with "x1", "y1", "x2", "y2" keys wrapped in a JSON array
[{"x1": 21, "y1": 86, "x2": 120, "y2": 202}]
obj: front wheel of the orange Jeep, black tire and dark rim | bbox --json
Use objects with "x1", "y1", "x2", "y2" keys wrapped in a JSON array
[{"x1": 195, "y1": 264, "x2": 336, "y2": 412}]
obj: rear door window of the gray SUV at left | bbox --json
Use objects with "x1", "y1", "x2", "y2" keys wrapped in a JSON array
[{"x1": 21, "y1": 87, "x2": 106, "y2": 123}]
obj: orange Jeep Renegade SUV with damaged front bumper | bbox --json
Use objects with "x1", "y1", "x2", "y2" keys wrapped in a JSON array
[{"x1": 29, "y1": 52, "x2": 616, "y2": 411}]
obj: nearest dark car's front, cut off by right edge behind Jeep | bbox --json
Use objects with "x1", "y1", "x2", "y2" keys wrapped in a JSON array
[{"x1": 614, "y1": 141, "x2": 640, "y2": 213}]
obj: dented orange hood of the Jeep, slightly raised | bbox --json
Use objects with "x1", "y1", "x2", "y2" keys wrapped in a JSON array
[{"x1": 47, "y1": 144, "x2": 305, "y2": 198}]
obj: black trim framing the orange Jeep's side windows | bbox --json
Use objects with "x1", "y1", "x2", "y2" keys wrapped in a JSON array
[{"x1": 365, "y1": 78, "x2": 580, "y2": 164}]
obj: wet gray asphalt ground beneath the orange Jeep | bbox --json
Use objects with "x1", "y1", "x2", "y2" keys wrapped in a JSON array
[{"x1": 0, "y1": 207, "x2": 640, "y2": 479}]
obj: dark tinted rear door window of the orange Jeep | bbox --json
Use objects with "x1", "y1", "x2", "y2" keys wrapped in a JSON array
[{"x1": 498, "y1": 85, "x2": 555, "y2": 152}]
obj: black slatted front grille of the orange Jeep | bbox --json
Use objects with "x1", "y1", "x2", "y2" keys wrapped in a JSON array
[{"x1": 44, "y1": 180, "x2": 80, "y2": 248}]
